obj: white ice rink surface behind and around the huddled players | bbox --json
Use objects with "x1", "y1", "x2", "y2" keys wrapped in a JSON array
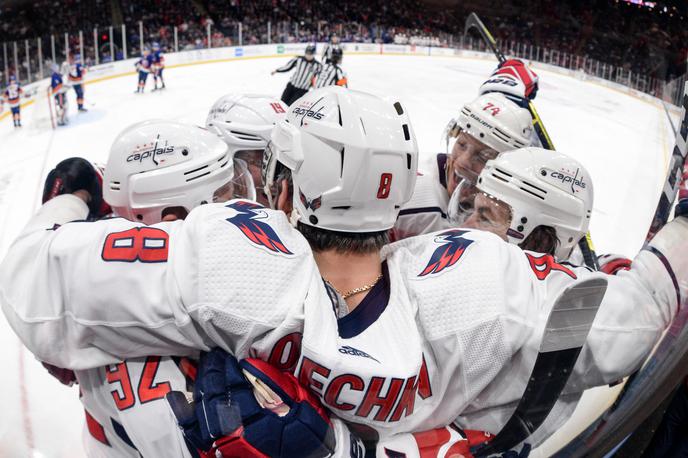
[{"x1": 0, "y1": 55, "x2": 673, "y2": 457}]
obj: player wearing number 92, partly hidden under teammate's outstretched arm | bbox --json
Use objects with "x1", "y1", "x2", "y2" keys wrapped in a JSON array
[{"x1": 46, "y1": 121, "x2": 254, "y2": 457}]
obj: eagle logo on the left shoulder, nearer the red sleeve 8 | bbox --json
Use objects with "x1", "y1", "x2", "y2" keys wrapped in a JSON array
[{"x1": 227, "y1": 200, "x2": 293, "y2": 254}]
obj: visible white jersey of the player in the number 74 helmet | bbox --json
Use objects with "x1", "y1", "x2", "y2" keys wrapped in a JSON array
[{"x1": 391, "y1": 154, "x2": 451, "y2": 240}]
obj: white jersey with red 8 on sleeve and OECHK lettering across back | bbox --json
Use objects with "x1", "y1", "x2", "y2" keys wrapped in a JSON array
[{"x1": 0, "y1": 195, "x2": 688, "y2": 448}]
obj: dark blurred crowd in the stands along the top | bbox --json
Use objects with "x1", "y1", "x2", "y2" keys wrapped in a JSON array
[{"x1": 0, "y1": 0, "x2": 688, "y2": 100}]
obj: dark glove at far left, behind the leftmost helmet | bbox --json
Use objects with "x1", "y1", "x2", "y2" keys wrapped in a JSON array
[{"x1": 42, "y1": 157, "x2": 112, "y2": 219}]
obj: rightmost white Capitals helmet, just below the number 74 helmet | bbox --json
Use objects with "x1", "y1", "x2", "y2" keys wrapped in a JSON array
[{"x1": 450, "y1": 147, "x2": 593, "y2": 259}]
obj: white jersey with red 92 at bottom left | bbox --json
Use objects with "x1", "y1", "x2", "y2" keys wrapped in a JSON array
[{"x1": 76, "y1": 356, "x2": 196, "y2": 458}]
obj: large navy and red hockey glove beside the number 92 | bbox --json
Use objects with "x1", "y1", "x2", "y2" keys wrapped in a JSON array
[{"x1": 167, "y1": 349, "x2": 335, "y2": 457}]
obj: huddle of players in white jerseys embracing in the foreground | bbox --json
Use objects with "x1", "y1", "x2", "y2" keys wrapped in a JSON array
[{"x1": 0, "y1": 54, "x2": 688, "y2": 457}]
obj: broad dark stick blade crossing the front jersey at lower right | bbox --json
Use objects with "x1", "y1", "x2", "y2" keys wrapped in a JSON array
[{"x1": 471, "y1": 276, "x2": 607, "y2": 458}]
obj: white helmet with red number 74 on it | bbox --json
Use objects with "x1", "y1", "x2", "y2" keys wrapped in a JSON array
[{"x1": 444, "y1": 92, "x2": 533, "y2": 153}]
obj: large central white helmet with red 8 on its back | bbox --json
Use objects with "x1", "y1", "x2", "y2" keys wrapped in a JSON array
[{"x1": 263, "y1": 86, "x2": 418, "y2": 232}]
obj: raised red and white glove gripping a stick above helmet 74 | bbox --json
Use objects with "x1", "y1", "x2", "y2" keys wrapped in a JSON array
[{"x1": 479, "y1": 59, "x2": 539, "y2": 101}]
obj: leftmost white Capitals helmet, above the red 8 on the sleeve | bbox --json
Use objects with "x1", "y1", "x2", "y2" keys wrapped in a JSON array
[{"x1": 103, "y1": 120, "x2": 253, "y2": 224}]
